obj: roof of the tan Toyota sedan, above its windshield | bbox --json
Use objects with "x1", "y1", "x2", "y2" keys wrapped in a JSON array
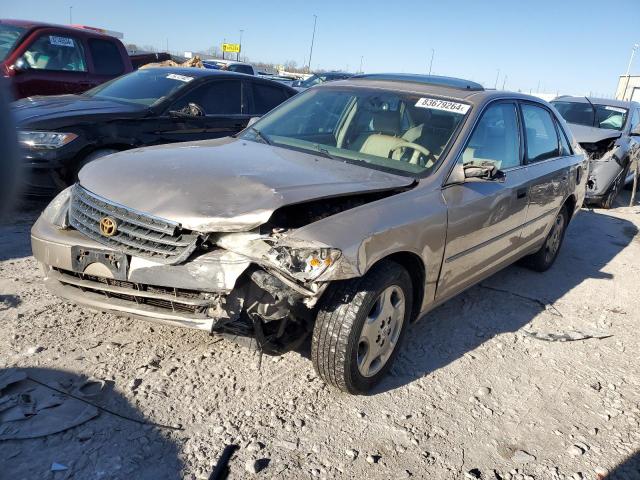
[{"x1": 324, "y1": 73, "x2": 547, "y2": 105}]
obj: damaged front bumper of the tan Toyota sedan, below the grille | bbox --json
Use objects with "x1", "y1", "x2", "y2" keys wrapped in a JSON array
[{"x1": 31, "y1": 218, "x2": 250, "y2": 331}]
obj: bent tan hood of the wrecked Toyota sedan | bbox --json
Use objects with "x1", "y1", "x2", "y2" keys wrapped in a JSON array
[{"x1": 79, "y1": 138, "x2": 413, "y2": 232}]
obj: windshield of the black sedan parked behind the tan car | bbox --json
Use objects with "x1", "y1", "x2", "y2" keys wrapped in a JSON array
[{"x1": 85, "y1": 69, "x2": 195, "y2": 107}]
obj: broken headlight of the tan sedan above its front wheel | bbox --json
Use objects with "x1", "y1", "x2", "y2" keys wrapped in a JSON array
[{"x1": 274, "y1": 246, "x2": 342, "y2": 281}]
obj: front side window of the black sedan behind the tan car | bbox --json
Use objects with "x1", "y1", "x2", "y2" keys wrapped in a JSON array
[{"x1": 171, "y1": 80, "x2": 242, "y2": 115}]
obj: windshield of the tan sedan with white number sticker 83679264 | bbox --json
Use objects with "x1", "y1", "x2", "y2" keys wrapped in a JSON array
[{"x1": 242, "y1": 87, "x2": 470, "y2": 175}]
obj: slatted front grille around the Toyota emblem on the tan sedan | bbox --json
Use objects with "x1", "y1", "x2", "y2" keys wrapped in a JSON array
[{"x1": 69, "y1": 184, "x2": 200, "y2": 264}]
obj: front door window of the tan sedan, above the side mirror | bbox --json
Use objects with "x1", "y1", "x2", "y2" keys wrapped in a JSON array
[{"x1": 462, "y1": 103, "x2": 521, "y2": 170}]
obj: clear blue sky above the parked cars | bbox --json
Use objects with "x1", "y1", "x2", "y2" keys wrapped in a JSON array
[{"x1": 6, "y1": 0, "x2": 640, "y2": 96}]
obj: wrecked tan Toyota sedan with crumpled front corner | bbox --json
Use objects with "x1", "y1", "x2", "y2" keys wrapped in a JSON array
[{"x1": 32, "y1": 74, "x2": 587, "y2": 393}]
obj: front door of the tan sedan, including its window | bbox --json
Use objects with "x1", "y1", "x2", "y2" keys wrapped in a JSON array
[{"x1": 436, "y1": 102, "x2": 529, "y2": 300}]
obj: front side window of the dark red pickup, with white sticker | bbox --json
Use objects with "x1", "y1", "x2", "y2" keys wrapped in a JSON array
[{"x1": 22, "y1": 33, "x2": 87, "y2": 72}]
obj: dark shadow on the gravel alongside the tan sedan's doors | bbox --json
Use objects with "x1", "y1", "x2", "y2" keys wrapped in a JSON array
[{"x1": 374, "y1": 210, "x2": 638, "y2": 393}]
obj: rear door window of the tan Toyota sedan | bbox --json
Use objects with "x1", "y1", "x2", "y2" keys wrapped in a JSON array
[{"x1": 522, "y1": 103, "x2": 560, "y2": 162}]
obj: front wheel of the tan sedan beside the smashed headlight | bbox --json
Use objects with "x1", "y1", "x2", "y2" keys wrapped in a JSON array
[{"x1": 311, "y1": 261, "x2": 413, "y2": 394}]
